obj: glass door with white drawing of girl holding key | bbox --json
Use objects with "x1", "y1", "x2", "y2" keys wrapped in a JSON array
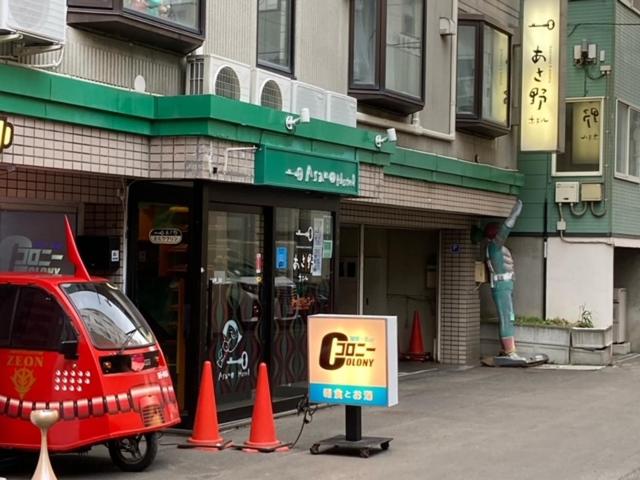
[{"x1": 207, "y1": 207, "x2": 264, "y2": 411}]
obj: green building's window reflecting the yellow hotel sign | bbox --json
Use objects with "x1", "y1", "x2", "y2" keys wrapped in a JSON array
[{"x1": 553, "y1": 98, "x2": 603, "y2": 176}]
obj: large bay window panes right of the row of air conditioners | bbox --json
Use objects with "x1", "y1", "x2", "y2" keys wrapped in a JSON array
[{"x1": 349, "y1": 0, "x2": 425, "y2": 115}]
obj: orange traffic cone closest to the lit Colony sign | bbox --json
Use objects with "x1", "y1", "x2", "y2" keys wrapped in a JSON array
[{"x1": 237, "y1": 363, "x2": 289, "y2": 452}]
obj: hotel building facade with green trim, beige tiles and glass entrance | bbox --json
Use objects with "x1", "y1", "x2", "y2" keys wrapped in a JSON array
[{"x1": 0, "y1": 0, "x2": 523, "y2": 420}]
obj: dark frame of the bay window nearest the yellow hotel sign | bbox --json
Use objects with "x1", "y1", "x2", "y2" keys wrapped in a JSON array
[{"x1": 456, "y1": 14, "x2": 513, "y2": 138}]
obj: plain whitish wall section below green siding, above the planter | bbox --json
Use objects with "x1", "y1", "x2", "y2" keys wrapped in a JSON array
[{"x1": 547, "y1": 238, "x2": 613, "y2": 327}]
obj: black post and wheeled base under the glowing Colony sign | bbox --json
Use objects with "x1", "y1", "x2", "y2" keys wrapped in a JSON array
[{"x1": 309, "y1": 405, "x2": 393, "y2": 458}]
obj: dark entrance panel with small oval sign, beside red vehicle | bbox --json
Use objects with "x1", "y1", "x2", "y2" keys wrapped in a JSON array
[{"x1": 133, "y1": 202, "x2": 191, "y2": 409}]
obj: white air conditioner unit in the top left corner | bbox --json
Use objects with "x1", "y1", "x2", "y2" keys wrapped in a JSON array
[{"x1": 0, "y1": 0, "x2": 67, "y2": 44}]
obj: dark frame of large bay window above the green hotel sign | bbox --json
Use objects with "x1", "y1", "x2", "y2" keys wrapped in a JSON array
[{"x1": 348, "y1": 0, "x2": 427, "y2": 115}]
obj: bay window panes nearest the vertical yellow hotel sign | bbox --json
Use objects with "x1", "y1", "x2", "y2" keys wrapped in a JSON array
[{"x1": 456, "y1": 17, "x2": 511, "y2": 138}]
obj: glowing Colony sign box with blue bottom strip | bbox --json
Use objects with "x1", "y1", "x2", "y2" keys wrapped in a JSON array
[{"x1": 308, "y1": 315, "x2": 398, "y2": 407}]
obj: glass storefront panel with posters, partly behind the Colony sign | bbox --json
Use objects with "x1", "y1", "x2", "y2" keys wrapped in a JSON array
[{"x1": 271, "y1": 208, "x2": 334, "y2": 395}]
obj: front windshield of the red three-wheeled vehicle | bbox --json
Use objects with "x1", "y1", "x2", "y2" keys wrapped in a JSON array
[{"x1": 62, "y1": 283, "x2": 155, "y2": 350}]
